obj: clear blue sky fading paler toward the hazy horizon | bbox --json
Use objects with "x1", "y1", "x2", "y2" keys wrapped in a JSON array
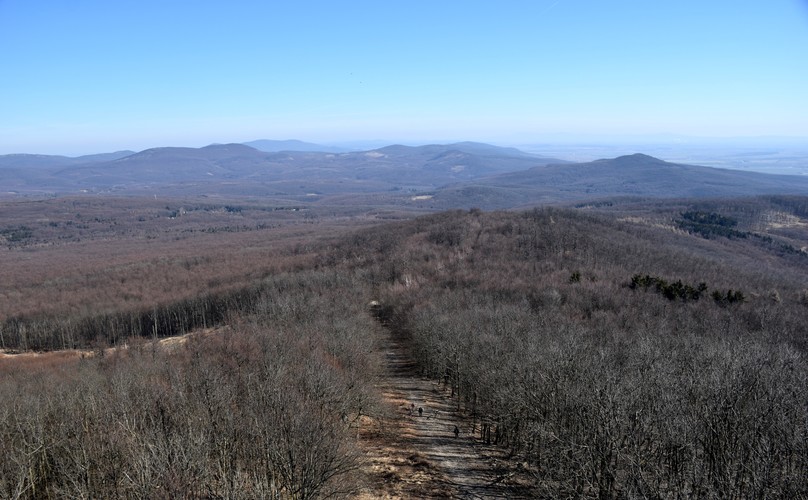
[{"x1": 0, "y1": 0, "x2": 808, "y2": 156}]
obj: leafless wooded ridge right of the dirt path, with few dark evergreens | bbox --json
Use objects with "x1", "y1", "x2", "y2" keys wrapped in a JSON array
[{"x1": 328, "y1": 206, "x2": 808, "y2": 498}]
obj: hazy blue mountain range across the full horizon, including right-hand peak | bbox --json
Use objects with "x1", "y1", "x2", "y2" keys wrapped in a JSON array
[{"x1": 0, "y1": 141, "x2": 808, "y2": 209}]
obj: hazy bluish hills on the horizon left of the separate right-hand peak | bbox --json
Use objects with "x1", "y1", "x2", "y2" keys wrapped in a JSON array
[{"x1": 0, "y1": 143, "x2": 561, "y2": 196}]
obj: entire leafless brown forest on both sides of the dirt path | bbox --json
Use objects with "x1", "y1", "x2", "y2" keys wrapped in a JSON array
[{"x1": 0, "y1": 197, "x2": 808, "y2": 498}]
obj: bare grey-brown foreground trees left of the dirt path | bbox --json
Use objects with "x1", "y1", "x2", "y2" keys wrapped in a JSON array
[{"x1": 0, "y1": 271, "x2": 380, "y2": 499}]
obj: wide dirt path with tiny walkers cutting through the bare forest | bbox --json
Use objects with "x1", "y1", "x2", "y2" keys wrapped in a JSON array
[{"x1": 360, "y1": 332, "x2": 530, "y2": 499}]
